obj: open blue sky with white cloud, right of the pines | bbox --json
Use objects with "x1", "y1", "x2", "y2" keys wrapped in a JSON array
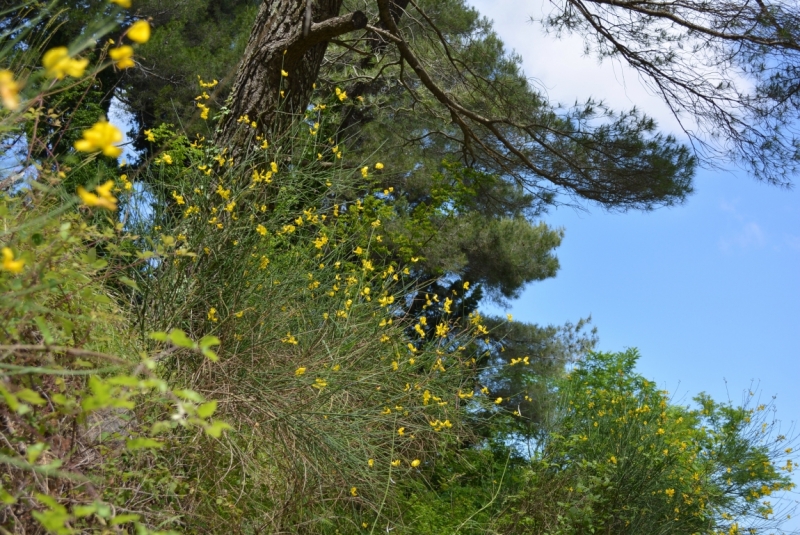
[{"x1": 470, "y1": 0, "x2": 800, "y2": 529}]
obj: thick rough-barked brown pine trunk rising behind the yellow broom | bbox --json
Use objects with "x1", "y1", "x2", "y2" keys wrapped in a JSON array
[{"x1": 216, "y1": 0, "x2": 367, "y2": 158}]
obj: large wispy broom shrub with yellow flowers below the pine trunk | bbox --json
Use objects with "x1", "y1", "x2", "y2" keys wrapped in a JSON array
[{"x1": 118, "y1": 99, "x2": 500, "y2": 533}]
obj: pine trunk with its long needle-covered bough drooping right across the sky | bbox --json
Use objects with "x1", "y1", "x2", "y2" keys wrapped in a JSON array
[{"x1": 217, "y1": 0, "x2": 694, "y2": 209}]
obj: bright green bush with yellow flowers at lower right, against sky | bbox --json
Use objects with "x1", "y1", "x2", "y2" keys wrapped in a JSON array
[{"x1": 500, "y1": 350, "x2": 797, "y2": 535}]
